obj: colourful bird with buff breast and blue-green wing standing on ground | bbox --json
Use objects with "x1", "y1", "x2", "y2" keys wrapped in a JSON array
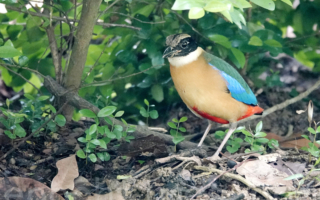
[{"x1": 163, "y1": 33, "x2": 263, "y2": 160}]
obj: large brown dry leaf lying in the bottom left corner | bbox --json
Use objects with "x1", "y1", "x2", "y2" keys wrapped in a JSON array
[{"x1": 0, "y1": 177, "x2": 64, "y2": 200}]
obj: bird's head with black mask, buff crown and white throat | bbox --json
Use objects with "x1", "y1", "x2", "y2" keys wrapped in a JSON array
[{"x1": 163, "y1": 33, "x2": 201, "y2": 67}]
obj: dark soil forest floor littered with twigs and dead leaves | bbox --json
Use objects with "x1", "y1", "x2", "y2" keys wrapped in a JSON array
[{"x1": 0, "y1": 54, "x2": 320, "y2": 200}]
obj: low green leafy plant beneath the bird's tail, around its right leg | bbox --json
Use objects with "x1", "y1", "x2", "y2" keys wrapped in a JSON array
[{"x1": 215, "y1": 121, "x2": 279, "y2": 153}]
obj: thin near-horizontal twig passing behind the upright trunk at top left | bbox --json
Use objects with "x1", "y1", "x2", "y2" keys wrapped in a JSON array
[{"x1": 6, "y1": 5, "x2": 141, "y2": 31}]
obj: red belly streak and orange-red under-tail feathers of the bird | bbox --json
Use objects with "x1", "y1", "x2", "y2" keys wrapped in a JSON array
[{"x1": 192, "y1": 106, "x2": 263, "y2": 124}]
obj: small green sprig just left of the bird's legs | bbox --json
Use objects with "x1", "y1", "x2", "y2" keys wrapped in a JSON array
[{"x1": 168, "y1": 117, "x2": 188, "y2": 145}]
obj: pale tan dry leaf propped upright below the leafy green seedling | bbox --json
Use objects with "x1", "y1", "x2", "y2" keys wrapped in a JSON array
[{"x1": 51, "y1": 155, "x2": 79, "y2": 192}]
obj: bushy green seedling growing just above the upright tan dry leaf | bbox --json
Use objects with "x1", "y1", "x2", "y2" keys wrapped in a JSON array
[{"x1": 76, "y1": 106, "x2": 135, "y2": 162}]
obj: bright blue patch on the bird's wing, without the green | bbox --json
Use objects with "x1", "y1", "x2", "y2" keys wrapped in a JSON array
[{"x1": 209, "y1": 63, "x2": 258, "y2": 105}]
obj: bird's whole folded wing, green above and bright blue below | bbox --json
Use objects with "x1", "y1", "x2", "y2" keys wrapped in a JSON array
[{"x1": 204, "y1": 52, "x2": 258, "y2": 105}]
